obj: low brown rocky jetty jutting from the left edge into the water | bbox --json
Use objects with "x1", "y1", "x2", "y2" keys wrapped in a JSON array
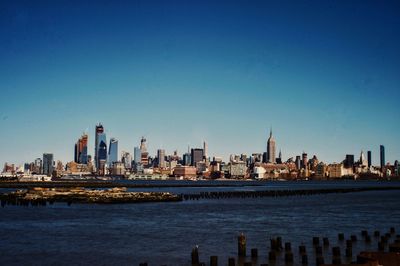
[{"x1": 0, "y1": 187, "x2": 182, "y2": 206}]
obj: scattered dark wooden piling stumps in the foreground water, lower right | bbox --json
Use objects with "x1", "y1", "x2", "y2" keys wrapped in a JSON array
[{"x1": 184, "y1": 227, "x2": 400, "y2": 266}]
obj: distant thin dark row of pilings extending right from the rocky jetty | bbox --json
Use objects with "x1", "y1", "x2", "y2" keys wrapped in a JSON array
[{"x1": 181, "y1": 187, "x2": 400, "y2": 200}]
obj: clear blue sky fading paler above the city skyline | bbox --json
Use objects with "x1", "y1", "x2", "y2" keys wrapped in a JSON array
[{"x1": 0, "y1": 0, "x2": 400, "y2": 164}]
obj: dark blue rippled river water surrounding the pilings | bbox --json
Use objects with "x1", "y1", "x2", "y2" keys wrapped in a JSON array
[{"x1": 0, "y1": 182, "x2": 400, "y2": 265}]
